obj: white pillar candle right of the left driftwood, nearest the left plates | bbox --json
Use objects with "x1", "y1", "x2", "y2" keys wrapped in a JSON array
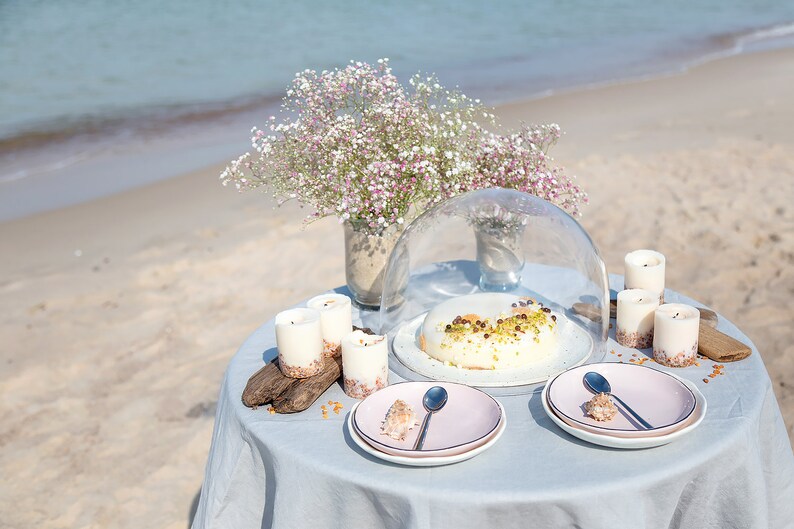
[{"x1": 342, "y1": 331, "x2": 389, "y2": 399}]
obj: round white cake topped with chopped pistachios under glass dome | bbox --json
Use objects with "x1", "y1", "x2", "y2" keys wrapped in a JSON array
[{"x1": 419, "y1": 293, "x2": 557, "y2": 369}]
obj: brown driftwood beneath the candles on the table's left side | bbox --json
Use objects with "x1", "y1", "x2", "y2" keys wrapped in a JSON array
[{"x1": 242, "y1": 326, "x2": 375, "y2": 413}]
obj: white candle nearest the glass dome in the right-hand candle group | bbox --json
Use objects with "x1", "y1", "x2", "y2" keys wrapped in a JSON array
[{"x1": 615, "y1": 288, "x2": 659, "y2": 349}]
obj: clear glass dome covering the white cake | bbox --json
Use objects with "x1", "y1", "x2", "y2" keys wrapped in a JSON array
[{"x1": 380, "y1": 188, "x2": 609, "y2": 394}]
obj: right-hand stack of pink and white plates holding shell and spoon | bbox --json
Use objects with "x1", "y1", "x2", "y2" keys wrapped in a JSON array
[{"x1": 542, "y1": 363, "x2": 706, "y2": 448}]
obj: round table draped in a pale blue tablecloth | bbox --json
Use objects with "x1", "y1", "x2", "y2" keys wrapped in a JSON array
[{"x1": 193, "y1": 276, "x2": 794, "y2": 529}]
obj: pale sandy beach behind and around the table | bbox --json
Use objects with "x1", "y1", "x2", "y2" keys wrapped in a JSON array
[{"x1": 0, "y1": 50, "x2": 794, "y2": 529}]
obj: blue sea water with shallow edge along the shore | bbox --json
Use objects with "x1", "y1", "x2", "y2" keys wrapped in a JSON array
[{"x1": 0, "y1": 0, "x2": 794, "y2": 219}]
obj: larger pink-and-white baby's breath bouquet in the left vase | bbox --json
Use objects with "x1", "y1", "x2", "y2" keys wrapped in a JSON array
[{"x1": 221, "y1": 59, "x2": 486, "y2": 235}]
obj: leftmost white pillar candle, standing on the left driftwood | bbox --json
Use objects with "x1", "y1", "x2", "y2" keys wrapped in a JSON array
[{"x1": 276, "y1": 309, "x2": 323, "y2": 378}]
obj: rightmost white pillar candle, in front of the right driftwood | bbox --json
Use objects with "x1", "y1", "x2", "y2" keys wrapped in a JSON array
[{"x1": 653, "y1": 303, "x2": 700, "y2": 367}]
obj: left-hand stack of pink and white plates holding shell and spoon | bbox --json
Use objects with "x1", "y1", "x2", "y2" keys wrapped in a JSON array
[{"x1": 347, "y1": 382, "x2": 506, "y2": 466}]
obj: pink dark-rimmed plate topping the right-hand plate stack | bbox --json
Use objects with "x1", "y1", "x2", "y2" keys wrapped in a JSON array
[{"x1": 548, "y1": 362, "x2": 696, "y2": 437}]
